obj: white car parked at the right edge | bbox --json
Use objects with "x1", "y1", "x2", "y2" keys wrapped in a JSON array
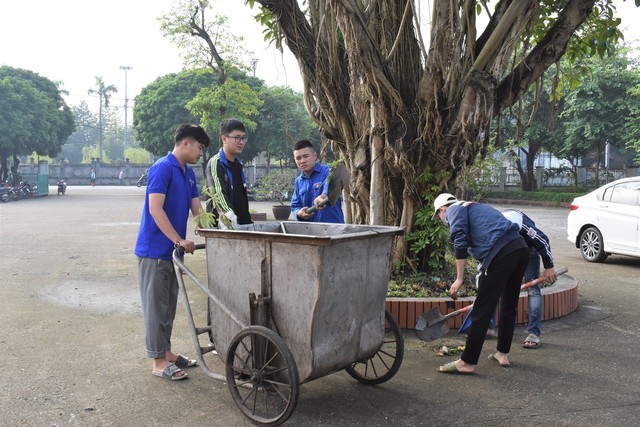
[{"x1": 567, "y1": 177, "x2": 640, "y2": 262}]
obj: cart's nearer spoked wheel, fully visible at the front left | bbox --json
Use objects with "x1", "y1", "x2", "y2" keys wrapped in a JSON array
[{"x1": 226, "y1": 325, "x2": 300, "y2": 426}]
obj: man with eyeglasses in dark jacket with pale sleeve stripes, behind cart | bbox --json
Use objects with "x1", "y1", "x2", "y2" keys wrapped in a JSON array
[{"x1": 207, "y1": 119, "x2": 253, "y2": 228}]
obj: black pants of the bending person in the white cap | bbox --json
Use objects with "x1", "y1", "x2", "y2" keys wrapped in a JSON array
[{"x1": 461, "y1": 241, "x2": 529, "y2": 365}]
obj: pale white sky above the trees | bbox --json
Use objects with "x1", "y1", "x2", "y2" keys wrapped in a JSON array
[{"x1": 0, "y1": 0, "x2": 640, "y2": 120}]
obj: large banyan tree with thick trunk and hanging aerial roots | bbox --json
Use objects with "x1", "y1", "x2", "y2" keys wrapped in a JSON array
[{"x1": 247, "y1": 0, "x2": 620, "y2": 268}]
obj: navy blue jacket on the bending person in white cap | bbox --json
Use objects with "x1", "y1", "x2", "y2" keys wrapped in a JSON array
[{"x1": 445, "y1": 201, "x2": 522, "y2": 271}]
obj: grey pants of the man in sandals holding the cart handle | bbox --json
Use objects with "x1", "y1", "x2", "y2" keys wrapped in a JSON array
[{"x1": 138, "y1": 257, "x2": 178, "y2": 359}]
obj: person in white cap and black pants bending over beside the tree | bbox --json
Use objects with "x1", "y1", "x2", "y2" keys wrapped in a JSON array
[{"x1": 432, "y1": 193, "x2": 529, "y2": 374}]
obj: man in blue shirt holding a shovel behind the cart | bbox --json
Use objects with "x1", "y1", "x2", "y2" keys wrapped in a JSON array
[{"x1": 291, "y1": 139, "x2": 344, "y2": 224}]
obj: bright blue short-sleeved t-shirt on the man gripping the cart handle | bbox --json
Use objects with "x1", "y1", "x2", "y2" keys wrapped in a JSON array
[{"x1": 134, "y1": 153, "x2": 198, "y2": 261}]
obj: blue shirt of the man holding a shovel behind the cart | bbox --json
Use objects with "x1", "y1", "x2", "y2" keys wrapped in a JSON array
[{"x1": 291, "y1": 162, "x2": 344, "y2": 224}]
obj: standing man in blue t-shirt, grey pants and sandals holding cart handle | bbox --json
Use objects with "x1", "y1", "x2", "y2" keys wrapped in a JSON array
[{"x1": 134, "y1": 124, "x2": 210, "y2": 381}]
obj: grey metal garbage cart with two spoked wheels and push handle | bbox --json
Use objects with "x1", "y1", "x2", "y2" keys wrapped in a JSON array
[{"x1": 173, "y1": 221, "x2": 404, "y2": 426}]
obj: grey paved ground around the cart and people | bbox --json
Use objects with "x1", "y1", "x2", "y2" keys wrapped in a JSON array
[{"x1": 0, "y1": 186, "x2": 640, "y2": 426}]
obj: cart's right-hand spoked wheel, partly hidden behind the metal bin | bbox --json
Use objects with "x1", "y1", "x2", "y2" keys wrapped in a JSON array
[{"x1": 345, "y1": 310, "x2": 404, "y2": 385}]
